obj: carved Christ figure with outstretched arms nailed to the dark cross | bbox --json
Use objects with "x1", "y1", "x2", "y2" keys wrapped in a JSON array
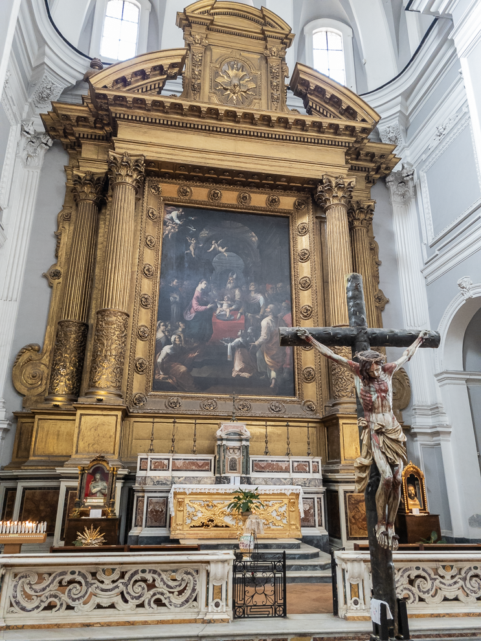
[{"x1": 297, "y1": 328, "x2": 429, "y2": 550}]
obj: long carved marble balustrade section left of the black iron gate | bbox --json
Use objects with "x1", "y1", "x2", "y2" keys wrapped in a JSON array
[{"x1": 0, "y1": 550, "x2": 234, "y2": 629}]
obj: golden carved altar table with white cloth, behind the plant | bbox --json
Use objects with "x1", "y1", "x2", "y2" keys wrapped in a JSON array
[{"x1": 169, "y1": 485, "x2": 304, "y2": 539}]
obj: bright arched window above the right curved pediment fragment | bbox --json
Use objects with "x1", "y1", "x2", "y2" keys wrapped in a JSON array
[{"x1": 304, "y1": 18, "x2": 356, "y2": 91}]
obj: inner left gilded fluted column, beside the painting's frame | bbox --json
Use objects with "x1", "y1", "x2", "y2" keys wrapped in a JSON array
[{"x1": 87, "y1": 152, "x2": 144, "y2": 397}]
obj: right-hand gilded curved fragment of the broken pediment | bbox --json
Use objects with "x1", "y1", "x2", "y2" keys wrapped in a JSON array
[{"x1": 291, "y1": 63, "x2": 381, "y2": 129}]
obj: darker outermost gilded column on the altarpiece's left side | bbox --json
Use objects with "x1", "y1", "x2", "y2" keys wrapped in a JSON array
[{"x1": 47, "y1": 172, "x2": 104, "y2": 402}]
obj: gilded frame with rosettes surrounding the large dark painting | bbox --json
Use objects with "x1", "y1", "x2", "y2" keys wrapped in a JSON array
[{"x1": 127, "y1": 177, "x2": 323, "y2": 420}]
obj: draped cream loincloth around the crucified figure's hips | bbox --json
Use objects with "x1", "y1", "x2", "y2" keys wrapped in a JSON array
[{"x1": 354, "y1": 419, "x2": 408, "y2": 492}]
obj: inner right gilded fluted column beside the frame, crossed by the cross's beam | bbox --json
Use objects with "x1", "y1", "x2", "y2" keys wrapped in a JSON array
[{"x1": 315, "y1": 175, "x2": 355, "y2": 401}]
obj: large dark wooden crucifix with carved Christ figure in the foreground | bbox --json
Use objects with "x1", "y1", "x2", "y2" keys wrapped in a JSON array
[{"x1": 279, "y1": 274, "x2": 440, "y2": 636}]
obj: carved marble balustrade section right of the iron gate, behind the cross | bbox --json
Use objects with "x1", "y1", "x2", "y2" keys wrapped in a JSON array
[{"x1": 334, "y1": 551, "x2": 481, "y2": 620}]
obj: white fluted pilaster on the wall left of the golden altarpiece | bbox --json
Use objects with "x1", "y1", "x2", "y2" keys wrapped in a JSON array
[{"x1": 0, "y1": 122, "x2": 52, "y2": 440}]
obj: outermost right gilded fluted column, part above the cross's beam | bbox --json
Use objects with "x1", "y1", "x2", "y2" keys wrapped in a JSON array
[{"x1": 347, "y1": 200, "x2": 377, "y2": 327}]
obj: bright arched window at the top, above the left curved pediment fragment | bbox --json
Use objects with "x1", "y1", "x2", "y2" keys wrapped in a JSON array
[{"x1": 100, "y1": 0, "x2": 140, "y2": 60}]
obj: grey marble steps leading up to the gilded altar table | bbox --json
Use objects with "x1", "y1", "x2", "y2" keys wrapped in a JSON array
[{"x1": 180, "y1": 539, "x2": 331, "y2": 583}]
